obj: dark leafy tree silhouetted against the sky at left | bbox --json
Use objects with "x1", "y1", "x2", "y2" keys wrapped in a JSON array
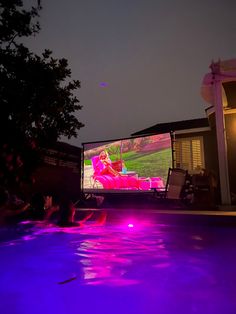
[{"x1": 0, "y1": 0, "x2": 83, "y2": 191}]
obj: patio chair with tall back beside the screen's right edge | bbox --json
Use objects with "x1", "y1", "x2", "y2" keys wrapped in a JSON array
[{"x1": 156, "y1": 168, "x2": 187, "y2": 200}]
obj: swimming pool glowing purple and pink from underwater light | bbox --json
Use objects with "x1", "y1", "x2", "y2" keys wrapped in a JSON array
[{"x1": 0, "y1": 210, "x2": 236, "y2": 314}]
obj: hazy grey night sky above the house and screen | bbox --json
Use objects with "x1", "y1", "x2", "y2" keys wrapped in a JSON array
[{"x1": 24, "y1": 0, "x2": 236, "y2": 146}]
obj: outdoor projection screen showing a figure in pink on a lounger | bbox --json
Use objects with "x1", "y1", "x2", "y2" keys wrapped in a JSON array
[{"x1": 82, "y1": 133, "x2": 172, "y2": 192}]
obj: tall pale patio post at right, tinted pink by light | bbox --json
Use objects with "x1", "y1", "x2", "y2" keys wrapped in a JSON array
[{"x1": 213, "y1": 73, "x2": 231, "y2": 205}]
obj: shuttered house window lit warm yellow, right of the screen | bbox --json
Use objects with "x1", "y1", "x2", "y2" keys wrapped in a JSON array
[{"x1": 174, "y1": 136, "x2": 205, "y2": 173}]
